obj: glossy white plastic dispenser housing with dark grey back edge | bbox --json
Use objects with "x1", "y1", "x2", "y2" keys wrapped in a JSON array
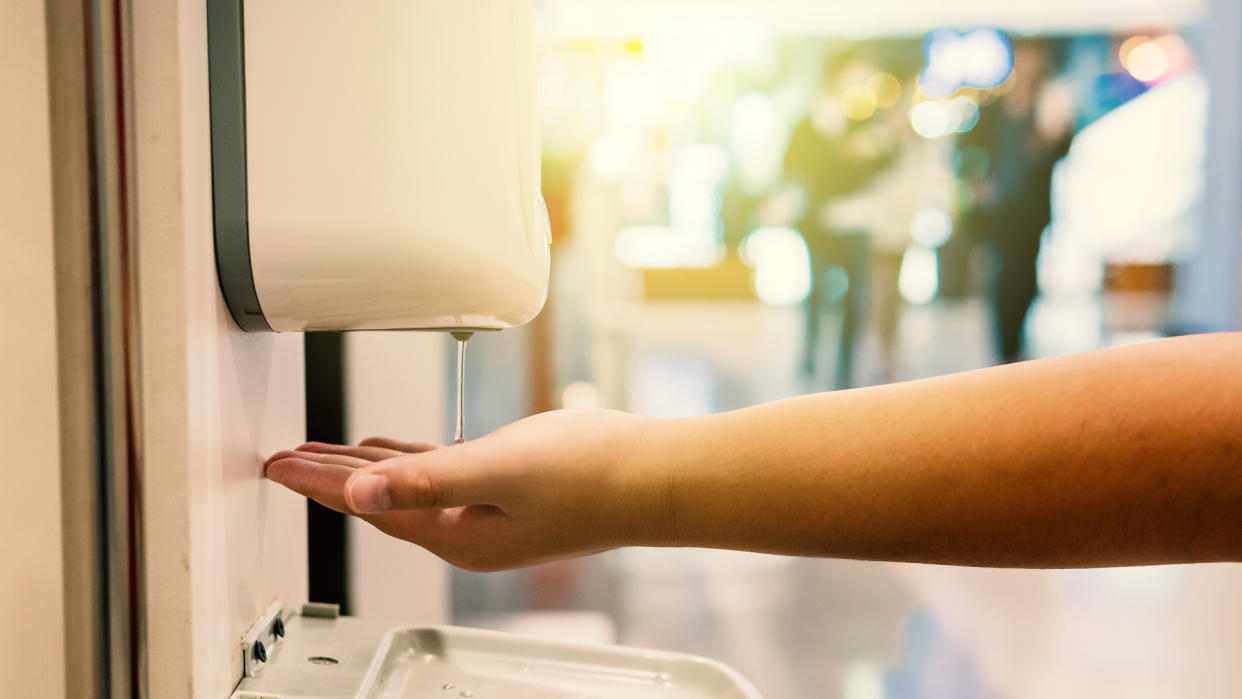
[{"x1": 207, "y1": 0, "x2": 549, "y2": 331}]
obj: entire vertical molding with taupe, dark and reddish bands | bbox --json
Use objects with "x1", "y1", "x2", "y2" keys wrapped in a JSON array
[{"x1": 46, "y1": 0, "x2": 147, "y2": 697}]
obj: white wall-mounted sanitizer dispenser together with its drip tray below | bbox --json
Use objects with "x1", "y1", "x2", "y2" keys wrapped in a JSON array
[{"x1": 206, "y1": 0, "x2": 758, "y2": 699}]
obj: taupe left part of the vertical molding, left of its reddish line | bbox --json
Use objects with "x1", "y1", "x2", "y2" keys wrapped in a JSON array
[{"x1": 47, "y1": 2, "x2": 111, "y2": 699}]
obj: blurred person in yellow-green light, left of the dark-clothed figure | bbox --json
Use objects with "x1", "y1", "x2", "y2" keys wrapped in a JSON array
[{"x1": 784, "y1": 47, "x2": 893, "y2": 389}]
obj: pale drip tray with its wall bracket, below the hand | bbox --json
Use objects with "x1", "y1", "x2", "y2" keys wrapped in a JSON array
[{"x1": 232, "y1": 603, "x2": 759, "y2": 699}]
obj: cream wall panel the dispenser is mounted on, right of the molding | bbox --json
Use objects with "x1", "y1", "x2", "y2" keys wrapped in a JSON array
[{"x1": 133, "y1": 0, "x2": 307, "y2": 699}]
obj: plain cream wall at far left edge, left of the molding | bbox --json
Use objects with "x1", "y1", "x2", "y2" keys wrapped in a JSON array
[{"x1": 0, "y1": 0, "x2": 65, "y2": 697}]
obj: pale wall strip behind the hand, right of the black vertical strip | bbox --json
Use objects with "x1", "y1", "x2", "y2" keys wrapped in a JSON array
[{"x1": 345, "y1": 333, "x2": 450, "y2": 625}]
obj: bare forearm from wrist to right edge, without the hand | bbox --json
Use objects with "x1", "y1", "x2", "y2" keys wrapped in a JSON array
[{"x1": 631, "y1": 335, "x2": 1242, "y2": 567}]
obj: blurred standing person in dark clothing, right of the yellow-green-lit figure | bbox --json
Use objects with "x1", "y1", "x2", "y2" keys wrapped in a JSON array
[{"x1": 961, "y1": 38, "x2": 1073, "y2": 363}]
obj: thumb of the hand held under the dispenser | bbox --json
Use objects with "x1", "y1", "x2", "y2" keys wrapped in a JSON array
[{"x1": 345, "y1": 443, "x2": 501, "y2": 514}]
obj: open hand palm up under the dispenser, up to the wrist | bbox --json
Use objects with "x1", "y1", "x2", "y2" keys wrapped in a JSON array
[{"x1": 265, "y1": 411, "x2": 668, "y2": 571}]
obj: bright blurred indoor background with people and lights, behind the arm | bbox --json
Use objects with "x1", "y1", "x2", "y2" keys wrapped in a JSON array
[{"x1": 445, "y1": 0, "x2": 1242, "y2": 699}]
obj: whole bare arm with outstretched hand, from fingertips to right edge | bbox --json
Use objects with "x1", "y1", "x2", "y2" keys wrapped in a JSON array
[{"x1": 268, "y1": 334, "x2": 1242, "y2": 570}]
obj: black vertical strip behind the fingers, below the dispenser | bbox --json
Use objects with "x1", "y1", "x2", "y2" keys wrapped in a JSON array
[{"x1": 306, "y1": 333, "x2": 349, "y2": 615}]
